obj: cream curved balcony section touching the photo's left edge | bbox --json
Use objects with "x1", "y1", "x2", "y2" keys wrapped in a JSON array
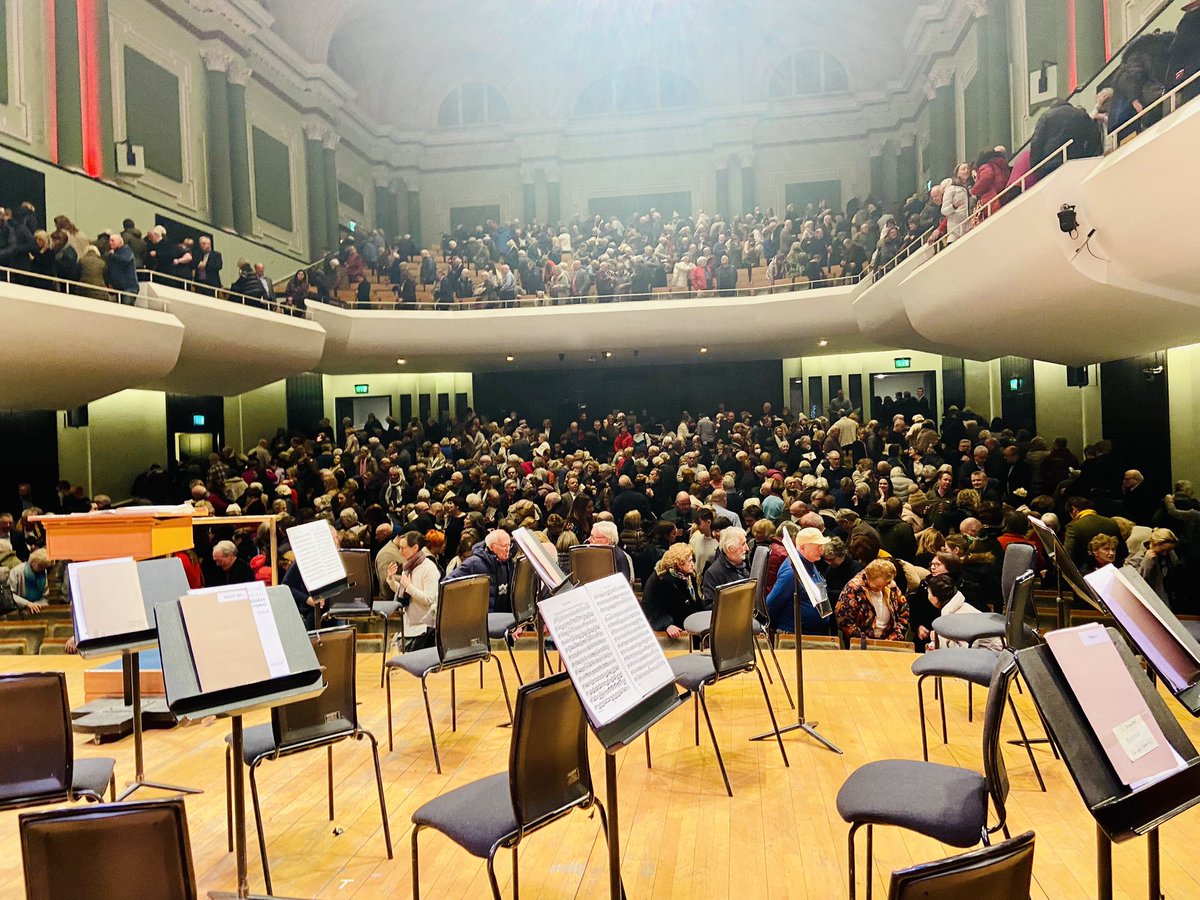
[{"x1": 0, "y1": 274, "x2": 184, "y2": 410}]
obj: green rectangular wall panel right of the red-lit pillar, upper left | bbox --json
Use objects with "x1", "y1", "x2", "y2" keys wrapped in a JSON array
[{"x1": 125, "y1": 47, "x2": 184, "y2": 181}]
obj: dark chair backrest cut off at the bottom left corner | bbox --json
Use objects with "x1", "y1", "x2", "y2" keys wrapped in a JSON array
[{"x1": 20, "y1": 797, "x2": 199, "y2": 900}]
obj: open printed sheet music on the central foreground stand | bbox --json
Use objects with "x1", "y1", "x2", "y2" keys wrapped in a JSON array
[{"x1": 538, "y1": 574, "x2": 674, "y2": 728}]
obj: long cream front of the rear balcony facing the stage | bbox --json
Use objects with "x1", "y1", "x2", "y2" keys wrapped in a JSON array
[{"x1": 308, "y1": 284, "x2": 877, "y2": 373}]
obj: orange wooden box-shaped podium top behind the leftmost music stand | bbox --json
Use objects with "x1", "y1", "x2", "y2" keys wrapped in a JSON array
[{"x1": 34, "y1": 506, "x2": 192, "y2": 563}]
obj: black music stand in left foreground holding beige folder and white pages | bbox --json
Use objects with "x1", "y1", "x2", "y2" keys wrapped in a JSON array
[{"x1": 155, "y1": 587, "x2": 325, "y2": 900}]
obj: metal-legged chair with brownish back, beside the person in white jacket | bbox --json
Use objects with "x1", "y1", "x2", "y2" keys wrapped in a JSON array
[{"x1": 386, "y1": 575, "x2": 512, "y2": 775}]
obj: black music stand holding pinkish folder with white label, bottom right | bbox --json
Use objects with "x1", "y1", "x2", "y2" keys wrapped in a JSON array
[{"x1": 1016, "y1": 628, "x2": 1200, "y2": 900}]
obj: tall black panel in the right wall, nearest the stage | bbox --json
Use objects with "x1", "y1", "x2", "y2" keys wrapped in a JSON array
[{"x1": 1100, "y1": 353, "x2": 1172, "y2": 497}]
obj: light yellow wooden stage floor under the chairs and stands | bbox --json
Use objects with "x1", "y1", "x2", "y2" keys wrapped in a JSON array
[{"x1": 0, "y1": 652, "x2": 1200, "y2": 900}]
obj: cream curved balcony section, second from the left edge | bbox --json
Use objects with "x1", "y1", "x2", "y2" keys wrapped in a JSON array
[{"x1": 140, "y1": 275, "x2": 325, "y2": 396}]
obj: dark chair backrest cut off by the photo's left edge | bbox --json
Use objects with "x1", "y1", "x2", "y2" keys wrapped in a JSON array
[{"x1": 0, "y1": 672, "x2": 73, "y2": 809}]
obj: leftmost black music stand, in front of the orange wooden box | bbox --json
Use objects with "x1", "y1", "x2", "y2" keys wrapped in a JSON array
[{"x1": 72, "y1": 557, "x2": 203, "y2": 800}]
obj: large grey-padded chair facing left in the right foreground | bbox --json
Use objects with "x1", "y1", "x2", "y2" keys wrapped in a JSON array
[{"x1": 838, "y1": 650, "x2": 1016, "y2": 900}]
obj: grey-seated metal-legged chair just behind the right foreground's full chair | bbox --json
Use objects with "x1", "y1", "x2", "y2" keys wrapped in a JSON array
[{"x1": 912, "y1": 571, "x2": 1058, "y2": 792}]
